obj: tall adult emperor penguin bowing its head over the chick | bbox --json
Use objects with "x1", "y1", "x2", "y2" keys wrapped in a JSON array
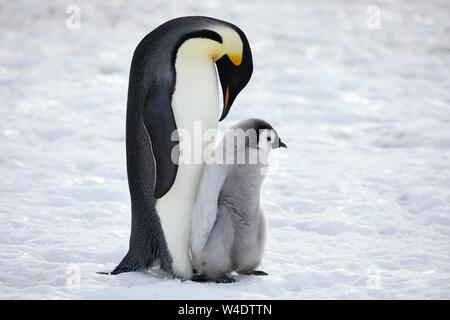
[{"x1": 112, "y1": 17, "x2": 253, "y2": 279}]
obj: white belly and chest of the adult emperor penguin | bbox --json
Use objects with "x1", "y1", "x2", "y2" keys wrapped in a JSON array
[{"x1": 156, "y1": 40, "x2": 219, "y2": 279}]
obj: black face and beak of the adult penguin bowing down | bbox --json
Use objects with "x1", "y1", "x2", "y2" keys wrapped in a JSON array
[{"x1": 216, "y1": 34, "x2": 253, "y2": 121}]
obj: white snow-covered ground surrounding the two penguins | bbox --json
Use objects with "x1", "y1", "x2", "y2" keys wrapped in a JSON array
[{"x1": 0, "y1": 0, "x2": 450, "y2": 299}]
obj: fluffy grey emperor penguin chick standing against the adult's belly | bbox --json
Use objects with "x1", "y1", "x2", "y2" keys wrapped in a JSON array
[{"x1": 190, "y1": 119, "x2": 286, "y2": 282}]
